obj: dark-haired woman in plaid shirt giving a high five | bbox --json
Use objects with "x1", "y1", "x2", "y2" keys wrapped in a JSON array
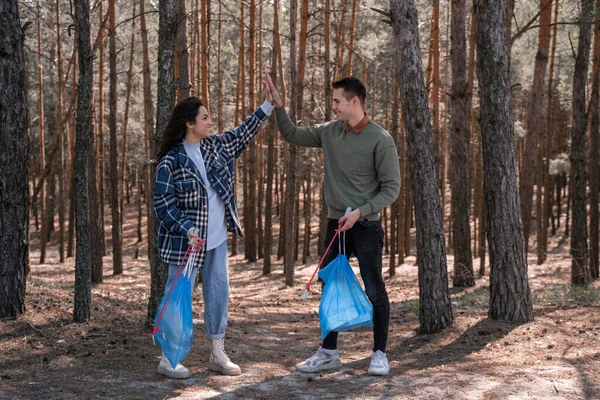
[{"x1": 154, "y1": 72, "x2": 274, "y2": 378}]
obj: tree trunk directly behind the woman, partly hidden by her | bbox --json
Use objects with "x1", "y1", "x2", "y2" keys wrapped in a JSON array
[{"x1": 147, "y1": 0, "x2": 177, "y2": 324}]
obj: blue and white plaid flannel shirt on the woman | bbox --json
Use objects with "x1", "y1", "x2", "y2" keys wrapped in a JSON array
[{"x1": 154, "y1": 108, "x2": 267, "y2": 267}]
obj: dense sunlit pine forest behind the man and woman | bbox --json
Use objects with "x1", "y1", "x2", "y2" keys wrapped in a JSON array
[{"x1": 0, "y1": 0, "x2": 600, "y2": 398}]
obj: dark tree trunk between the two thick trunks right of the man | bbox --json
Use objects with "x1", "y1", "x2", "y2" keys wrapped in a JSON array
[{"x1": 446, "y1": 0, "x2": 475, "y2": 287}]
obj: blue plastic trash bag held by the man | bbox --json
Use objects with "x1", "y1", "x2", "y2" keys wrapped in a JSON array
[{"x1": 319, "y1": 254, "x2": 373, "y2": 339}]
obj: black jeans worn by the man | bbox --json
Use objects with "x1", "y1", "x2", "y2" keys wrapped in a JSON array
[{"x1": 322, "y1": 219, "x2": 390, "y2": 353}]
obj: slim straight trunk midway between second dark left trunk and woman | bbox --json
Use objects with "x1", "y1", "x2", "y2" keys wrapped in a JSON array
[{"x1": 108, "y1": 0, "x2": 123, "y2": 275}]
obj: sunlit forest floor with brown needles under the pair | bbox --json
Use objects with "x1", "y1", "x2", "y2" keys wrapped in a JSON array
[{"x1": 0, "y1": 203, "x2": 600, "y2": 400}]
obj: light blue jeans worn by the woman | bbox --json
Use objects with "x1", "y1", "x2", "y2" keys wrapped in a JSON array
[{"x1": 166, "y1": 241, "x2": 229, "y2": 339}]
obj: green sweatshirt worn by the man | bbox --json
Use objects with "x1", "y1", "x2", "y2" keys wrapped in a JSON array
[{"x1": 276, "y1": 107, "x2": 400, "y2": 221}]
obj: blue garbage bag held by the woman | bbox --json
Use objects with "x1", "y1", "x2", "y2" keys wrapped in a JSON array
[{"x1": 152, "y1": 273, "x2": 194, "y2": 368}]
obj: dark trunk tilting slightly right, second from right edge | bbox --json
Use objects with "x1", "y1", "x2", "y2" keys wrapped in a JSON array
[{"x1": 569, "y1": 0, "x2": 594, "y2": 285}]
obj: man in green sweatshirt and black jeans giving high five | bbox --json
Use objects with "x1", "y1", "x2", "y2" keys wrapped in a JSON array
[{"x1": 267, "y1": 77, "x2": 400, "y2": 375}]
